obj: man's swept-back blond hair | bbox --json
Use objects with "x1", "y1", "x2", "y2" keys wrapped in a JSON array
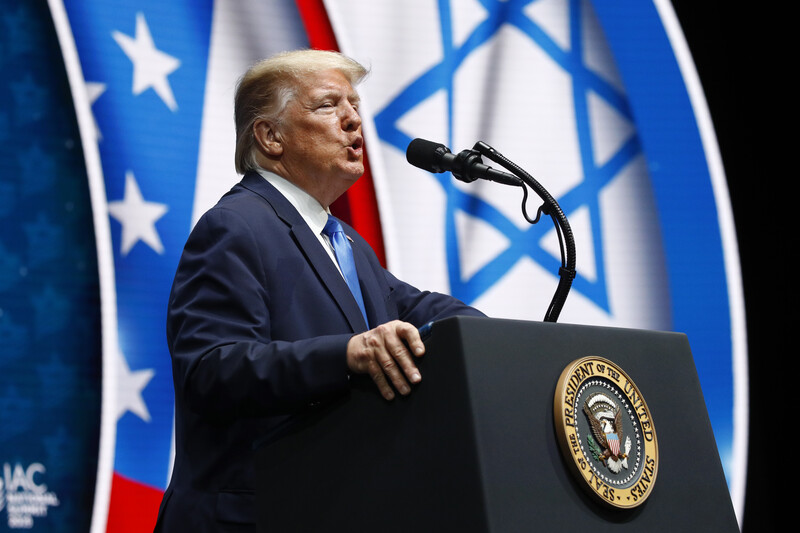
[{"x1": 234, "y1": 50, "x2": 368, "y2": 174}]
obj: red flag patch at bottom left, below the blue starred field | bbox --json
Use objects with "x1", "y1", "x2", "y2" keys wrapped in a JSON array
[{"x1": 106, "y1": 472, "x2": 164, "y2": 533}]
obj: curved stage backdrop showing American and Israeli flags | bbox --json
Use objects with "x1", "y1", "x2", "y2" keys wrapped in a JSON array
[{"x1": 0, "y1": 0, "x2": 748, "y2": 532}]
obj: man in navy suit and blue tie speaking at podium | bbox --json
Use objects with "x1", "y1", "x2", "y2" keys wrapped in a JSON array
[{"x1": 156, "y1": 50, "x2": 480, "y2": 533}]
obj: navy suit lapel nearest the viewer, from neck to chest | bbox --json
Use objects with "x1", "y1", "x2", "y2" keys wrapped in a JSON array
[{"x1": 241, "y1": 172, "x2": 367, "y2": 332}]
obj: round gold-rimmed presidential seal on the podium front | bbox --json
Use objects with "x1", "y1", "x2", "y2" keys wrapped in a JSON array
[{"x1": 553, "y1": 356, "x2": 658, "y2": 509}]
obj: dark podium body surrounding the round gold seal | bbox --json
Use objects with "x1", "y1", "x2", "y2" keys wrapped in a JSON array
[{"x1": 255, "y1": 317, "x2": 739, "y2": 533}]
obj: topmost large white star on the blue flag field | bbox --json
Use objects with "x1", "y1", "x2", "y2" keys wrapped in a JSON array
[{"x1": 111, "y1": 13, "x2": 181, "y2": 111}]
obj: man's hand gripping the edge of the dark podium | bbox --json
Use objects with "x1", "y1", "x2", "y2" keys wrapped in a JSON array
[{"x1": 347, "y1": 320, "x2": 425, "y2": 400}]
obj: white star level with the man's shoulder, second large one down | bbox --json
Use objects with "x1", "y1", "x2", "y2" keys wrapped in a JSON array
[{"x1": 108, "y1": 171, "x2": 167, "y2": 255}]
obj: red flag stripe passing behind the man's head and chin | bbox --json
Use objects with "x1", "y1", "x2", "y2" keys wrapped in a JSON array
[{"x1": 295, "y1": 0, "x2": 386, "y2": 267}]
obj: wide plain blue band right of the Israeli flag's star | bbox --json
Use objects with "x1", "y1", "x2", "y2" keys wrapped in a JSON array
[{"x1": 595, "y1": 1, "x2": 744, "y2": 482}]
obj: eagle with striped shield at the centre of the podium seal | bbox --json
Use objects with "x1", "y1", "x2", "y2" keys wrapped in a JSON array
[{"x1": 583, "y1": 392, "x2": 631, "y2": 474}]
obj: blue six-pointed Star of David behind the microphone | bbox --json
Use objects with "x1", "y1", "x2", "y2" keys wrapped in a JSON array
[{"x1": 375, "y1": 0, "x2": 641, "y2": 311}]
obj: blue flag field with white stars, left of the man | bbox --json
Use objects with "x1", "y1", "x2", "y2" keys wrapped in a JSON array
[{"x1": 65, "y1": 0, "x2": 212, "y2": 488}]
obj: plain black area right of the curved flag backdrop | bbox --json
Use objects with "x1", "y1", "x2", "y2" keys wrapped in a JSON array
[{"x1": 673, "y1": 0, "x2": 784, "y2": 533}]
